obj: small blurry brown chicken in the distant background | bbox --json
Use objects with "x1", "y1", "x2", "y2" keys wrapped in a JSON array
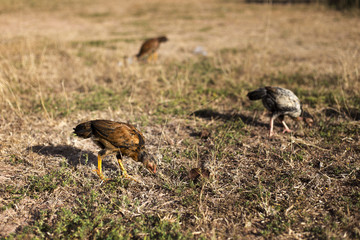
[{"x1": 136, "y1": 36, "x2": 168, "y2": 62}]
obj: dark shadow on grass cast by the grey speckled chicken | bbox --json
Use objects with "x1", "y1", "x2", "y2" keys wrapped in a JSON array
[{"x1": 190, "y1": 109, "x2": 268, "y2": 127}]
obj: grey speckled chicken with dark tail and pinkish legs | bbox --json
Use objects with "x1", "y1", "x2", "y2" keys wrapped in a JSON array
[{"x1": 247, "y1": 87, "x2": 313, "y2": 137}]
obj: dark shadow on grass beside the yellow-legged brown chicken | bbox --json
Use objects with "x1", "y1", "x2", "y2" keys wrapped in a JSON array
[{"x1": 27, "y1": 145, "x2": 115, "y2": 169}]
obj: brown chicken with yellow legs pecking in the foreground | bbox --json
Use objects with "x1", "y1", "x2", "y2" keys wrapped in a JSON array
[{"x1": 74, "y1": 120, "x2": 156, "y2": 181}]
